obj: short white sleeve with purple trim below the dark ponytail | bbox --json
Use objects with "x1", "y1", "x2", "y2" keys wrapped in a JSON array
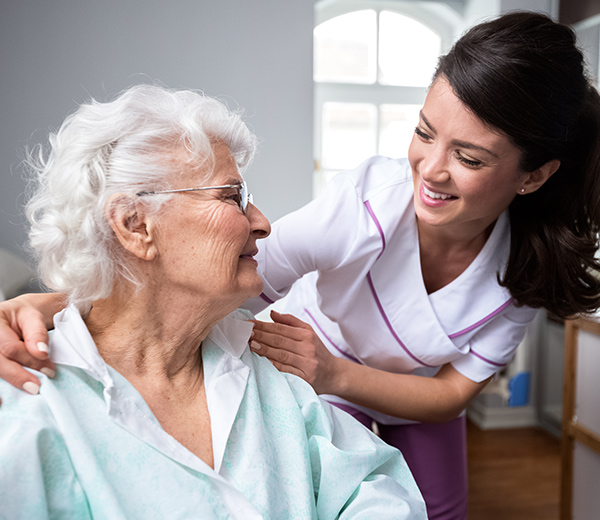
[{"x1": 452, "y1": 304, "x2": 538, "y2": 383}]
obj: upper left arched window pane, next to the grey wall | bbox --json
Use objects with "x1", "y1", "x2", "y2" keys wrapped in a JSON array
[{"x1": 314, "y1": 10, "x2": 377, "y2": 84}]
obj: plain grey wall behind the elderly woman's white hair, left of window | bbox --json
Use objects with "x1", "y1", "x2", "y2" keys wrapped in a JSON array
[{"x1": 0, "y1": 0, "x2": 313, "y2": 260}]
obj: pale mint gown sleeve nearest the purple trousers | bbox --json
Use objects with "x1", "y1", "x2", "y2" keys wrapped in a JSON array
[{"x1": 287, "y1": 375, "x2": 427, "y2": 520}]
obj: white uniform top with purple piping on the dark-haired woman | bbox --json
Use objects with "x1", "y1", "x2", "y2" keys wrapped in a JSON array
[{"x1": 246, "y1": 157, "x2": 537, "y2": 424}]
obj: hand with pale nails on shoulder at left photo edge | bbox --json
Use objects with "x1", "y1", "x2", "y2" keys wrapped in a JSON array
[{"x1": 0, "y1": 294, "x2": 62, "y2": 394}]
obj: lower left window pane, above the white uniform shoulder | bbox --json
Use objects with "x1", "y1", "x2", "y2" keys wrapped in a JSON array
[{"x1": 322, "y1": 103, "x2": 377, "y2": 170}]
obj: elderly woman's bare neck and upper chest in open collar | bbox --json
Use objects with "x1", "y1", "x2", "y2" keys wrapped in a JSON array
[{"x1": 85, "y1": 284, "x2": 227, "y2": 467}]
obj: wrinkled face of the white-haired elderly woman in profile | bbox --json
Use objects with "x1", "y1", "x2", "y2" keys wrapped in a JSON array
[{"x1": 157, "y1": 143, "x2": 270, "y2": 308}]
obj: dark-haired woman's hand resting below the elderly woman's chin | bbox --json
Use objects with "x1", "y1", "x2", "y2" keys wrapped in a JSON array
[{"x1": 250, "y1": 311, "x2": 338, "y2": 394}]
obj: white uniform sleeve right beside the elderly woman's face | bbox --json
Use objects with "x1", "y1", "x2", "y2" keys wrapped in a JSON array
[{"x1": 244, "y1": 173, "x2": 363, "y2": 313}]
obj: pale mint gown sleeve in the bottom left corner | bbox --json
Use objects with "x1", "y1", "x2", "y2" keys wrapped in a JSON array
[{"x1": 0, "y1": 381, "x2": 92, "y2": 520}]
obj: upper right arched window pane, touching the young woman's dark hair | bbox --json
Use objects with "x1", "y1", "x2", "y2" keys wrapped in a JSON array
[{"x1": 379, "y1": 11, "x2": 442, "y2": 87}]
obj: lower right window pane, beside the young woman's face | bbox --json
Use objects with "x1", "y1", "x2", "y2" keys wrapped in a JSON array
[{"x1": 379, "y1": 105, "x2": 421, "y2": 157}]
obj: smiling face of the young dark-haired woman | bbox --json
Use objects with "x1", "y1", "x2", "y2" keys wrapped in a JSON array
[{"x1": 408, "y1": 76, "x2": 525, "y2": 237}]
